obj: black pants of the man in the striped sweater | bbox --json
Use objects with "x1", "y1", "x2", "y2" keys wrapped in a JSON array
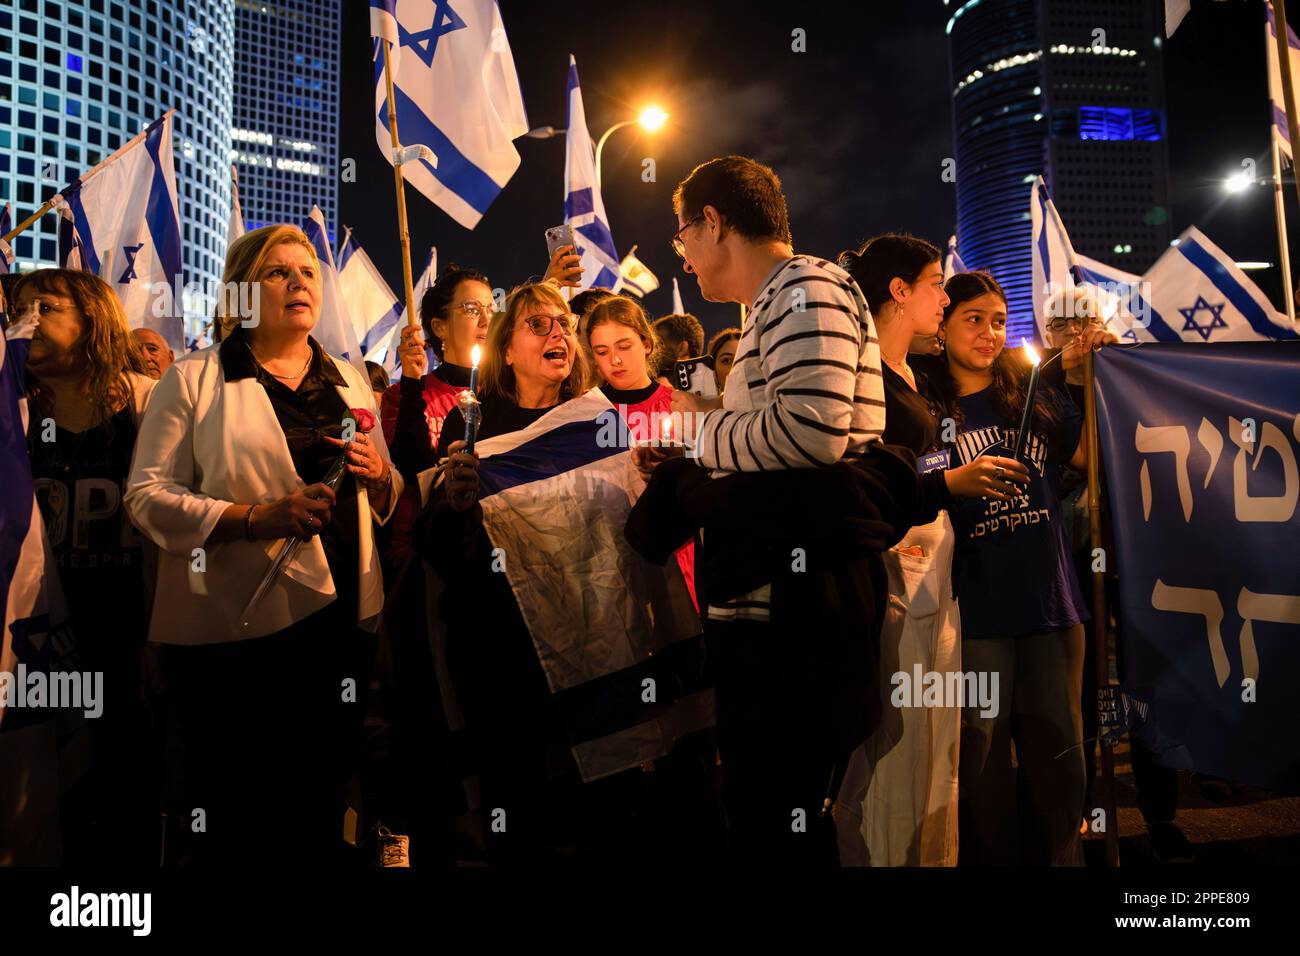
[{"x1": 705, "y1": 620, "x2": 849, "y2": 868}]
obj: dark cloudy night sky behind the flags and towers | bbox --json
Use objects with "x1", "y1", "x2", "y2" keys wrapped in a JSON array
[{"x1": 339, "y1": 0, "x2": 1300, "y2": 332}]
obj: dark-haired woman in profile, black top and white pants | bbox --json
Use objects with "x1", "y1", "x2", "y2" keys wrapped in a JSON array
[{"x1": 837, "y1": 233, "x2": 1024, "y2": 866}]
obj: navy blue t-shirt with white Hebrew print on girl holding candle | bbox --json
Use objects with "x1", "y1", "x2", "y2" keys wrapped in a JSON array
[{"x1": 953, "y1": 388, "x2": 1088, "y2": 640}]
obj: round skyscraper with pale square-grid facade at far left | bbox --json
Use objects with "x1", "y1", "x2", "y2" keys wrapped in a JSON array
[{"x1": 0, "y1": 0, "x2": 234, "y2": 316}]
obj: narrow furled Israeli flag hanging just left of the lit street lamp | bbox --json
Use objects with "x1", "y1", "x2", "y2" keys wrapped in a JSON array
[{"x1": 564, "y1": 53, "x2": 623, "y2": 293}]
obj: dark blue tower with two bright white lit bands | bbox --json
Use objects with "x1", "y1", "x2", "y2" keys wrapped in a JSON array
[{"x1": 231, "y1": 0, "x2": 339, "y2": 247}]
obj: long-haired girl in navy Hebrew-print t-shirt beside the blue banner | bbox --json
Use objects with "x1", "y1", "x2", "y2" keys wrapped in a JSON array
[{"x1": 933, "y1": 272, "x2": 1088, "y2": 866}]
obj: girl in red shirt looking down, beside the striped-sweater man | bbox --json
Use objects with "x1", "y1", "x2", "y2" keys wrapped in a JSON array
[{"x1": 585, "y1": 295, "x2": 699, "y2": 610}]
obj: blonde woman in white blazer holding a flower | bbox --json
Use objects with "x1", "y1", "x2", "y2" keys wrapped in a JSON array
[{"x1": 126, "y1": 225, "x2": 402, "y2": 864}]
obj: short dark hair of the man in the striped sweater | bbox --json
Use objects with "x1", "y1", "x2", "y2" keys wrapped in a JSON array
[{"x1": 672, "y1": 156, "x2": 792, "y2": 242}]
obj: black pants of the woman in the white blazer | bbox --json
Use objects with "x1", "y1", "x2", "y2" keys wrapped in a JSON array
[{"x1": 161, "y1": 602, "x2": 374, "y2": 868}]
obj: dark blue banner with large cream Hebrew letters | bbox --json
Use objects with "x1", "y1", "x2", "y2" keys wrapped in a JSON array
[{"x1": 1095, "y1": 342, "x2": 1300, "y2": 792}]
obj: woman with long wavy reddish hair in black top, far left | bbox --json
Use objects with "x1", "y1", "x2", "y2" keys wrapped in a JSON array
[{"x1": 14, "y1": 269, "x2": 157, "y2": 865}]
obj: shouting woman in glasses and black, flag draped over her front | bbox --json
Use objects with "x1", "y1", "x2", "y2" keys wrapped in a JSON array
[{"x1": 413, "y1": 284, "x2": 588, "y2": 858}]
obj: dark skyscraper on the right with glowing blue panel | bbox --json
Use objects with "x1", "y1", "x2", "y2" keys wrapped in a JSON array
[{"x1": 945, "y1": 0, "x2": 1171, "y2": 342}]
